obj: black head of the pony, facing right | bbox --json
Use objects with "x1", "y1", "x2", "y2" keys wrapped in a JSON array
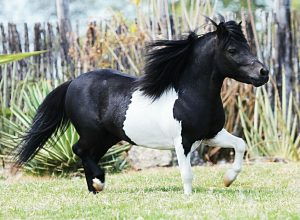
[{"x1": 212, "y1": 21, "x2": 269, "y2": 86}]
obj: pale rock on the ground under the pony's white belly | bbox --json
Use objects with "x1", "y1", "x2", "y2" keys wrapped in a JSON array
[{"x1": 127, "y1": 146, "x2": 172, "y2": 170}]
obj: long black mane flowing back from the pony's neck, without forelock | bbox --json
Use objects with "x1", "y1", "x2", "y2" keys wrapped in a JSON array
[{"x1": 137, "y1": 32, "x2": 198, "y2": 100}]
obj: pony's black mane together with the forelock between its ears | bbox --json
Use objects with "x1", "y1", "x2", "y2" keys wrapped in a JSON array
[{"x1": 136, "y1": 20, "x2": 247, "y2": 100}]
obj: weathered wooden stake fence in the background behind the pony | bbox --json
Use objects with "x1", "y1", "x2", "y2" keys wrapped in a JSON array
[{"x1": 0, "y1": 9, "x2": 300, "y2": 101}]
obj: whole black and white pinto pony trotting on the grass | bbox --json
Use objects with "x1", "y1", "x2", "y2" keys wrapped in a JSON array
[{"x1": 16, "y1": 21, "x2": 269, "y2": 194}]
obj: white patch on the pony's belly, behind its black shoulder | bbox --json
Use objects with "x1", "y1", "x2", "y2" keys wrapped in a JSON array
[{"x1": 123, "y1": 89, "x2": 181, "y2": 149}]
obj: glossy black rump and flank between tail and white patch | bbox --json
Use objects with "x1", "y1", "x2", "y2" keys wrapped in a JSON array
[{"x1": 65, "y1": 69, "x2": 135, "y2": 139}]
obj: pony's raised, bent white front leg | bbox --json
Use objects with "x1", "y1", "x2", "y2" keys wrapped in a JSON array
[{"x1": 204, "y1": 129, "x2": 246, "y2": 187}]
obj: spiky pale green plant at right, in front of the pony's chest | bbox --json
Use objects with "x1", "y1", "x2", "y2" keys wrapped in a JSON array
[{"x1": 239, "y1": 77, "x2": 300, "y2": 161}]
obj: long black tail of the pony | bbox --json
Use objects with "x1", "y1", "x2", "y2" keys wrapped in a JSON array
[{"x1": 15, "y1": 81, "x2": 71, "y2": 166}]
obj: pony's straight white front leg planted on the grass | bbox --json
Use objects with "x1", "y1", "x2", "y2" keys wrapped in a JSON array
[{"x1": 174, "y1": 137, "x2": 193, "y2": 195}]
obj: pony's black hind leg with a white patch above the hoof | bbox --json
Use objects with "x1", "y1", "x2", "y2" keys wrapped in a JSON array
[{"x1": 73, "y1": 135, "x2": 118, "y2": 193}]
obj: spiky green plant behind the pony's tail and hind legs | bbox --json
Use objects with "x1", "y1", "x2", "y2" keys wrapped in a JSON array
[{"x1": 0, "y1": 80, "x2": 129, "y2": 174}]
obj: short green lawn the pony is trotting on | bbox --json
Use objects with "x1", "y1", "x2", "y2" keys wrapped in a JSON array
[{"x1": 0, "y1": 163, "x2": 300, "y2": 219}]
